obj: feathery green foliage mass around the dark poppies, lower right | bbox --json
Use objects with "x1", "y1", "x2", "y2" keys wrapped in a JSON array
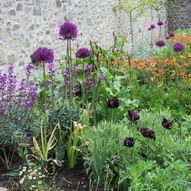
[{"x1": 82, "y1": 110, "x2": 191, "y2": 191}]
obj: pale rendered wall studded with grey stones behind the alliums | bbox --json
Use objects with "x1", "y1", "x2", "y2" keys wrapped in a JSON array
[{"x1": 0, "y1": 0, "x2": 165, "y2": 73}]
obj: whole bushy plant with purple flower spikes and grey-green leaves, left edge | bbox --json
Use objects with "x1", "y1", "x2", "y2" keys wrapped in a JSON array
[{"x1": 0, "y1": 64, "x2": 37, "y2": 169}]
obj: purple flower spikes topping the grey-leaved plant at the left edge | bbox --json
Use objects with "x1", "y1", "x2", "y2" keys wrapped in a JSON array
[{"x1": 0, "y1": 65, "x2": 37, "y2": 114}]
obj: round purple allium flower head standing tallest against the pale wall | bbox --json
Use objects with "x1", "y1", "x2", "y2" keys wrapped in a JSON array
[{"x1": 59, "y1": 21, "x2": 77, "y2": 40}]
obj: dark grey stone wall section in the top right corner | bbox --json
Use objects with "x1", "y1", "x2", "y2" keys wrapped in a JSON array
[{"x1": 167, "y1": 0, "x2": 191, "y2": 31}]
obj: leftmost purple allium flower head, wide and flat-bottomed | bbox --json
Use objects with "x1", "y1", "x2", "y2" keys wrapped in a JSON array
[{"x1": 33, "y1": 47, "x2": 54, "y2": 63}]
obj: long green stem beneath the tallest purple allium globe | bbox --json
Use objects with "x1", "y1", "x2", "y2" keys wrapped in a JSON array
[{"x1": 67, "y1": 39, "x2": 73, "y2": 130}]
